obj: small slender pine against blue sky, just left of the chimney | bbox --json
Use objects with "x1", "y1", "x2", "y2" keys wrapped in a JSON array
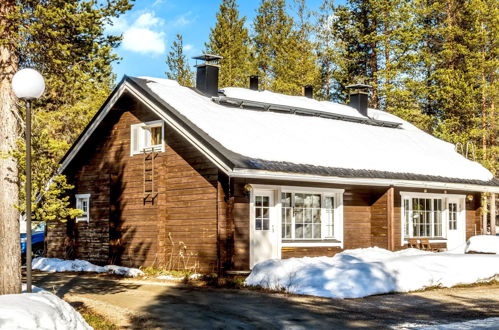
[{"x1": 166, "y1": 34, "x2": 194, "y2": 87}]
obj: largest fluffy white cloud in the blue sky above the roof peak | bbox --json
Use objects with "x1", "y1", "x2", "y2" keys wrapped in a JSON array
[{"x1": 106, "y1": 11, "x2": 166, "y2": 55}]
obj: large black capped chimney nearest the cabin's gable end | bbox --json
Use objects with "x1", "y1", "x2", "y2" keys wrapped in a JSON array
[{"x1": 193, "y1": 54, "x2": 222, "y2": 96}]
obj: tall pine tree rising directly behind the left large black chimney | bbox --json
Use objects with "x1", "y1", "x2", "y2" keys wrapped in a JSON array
[{"x1": 206, "y1": 0, "x2": 256, "y2": 87}]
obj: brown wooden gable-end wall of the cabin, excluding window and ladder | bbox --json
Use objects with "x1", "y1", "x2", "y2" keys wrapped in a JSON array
[{"x1": 48, "y1": 98, "x2": 221, "y2": 272}]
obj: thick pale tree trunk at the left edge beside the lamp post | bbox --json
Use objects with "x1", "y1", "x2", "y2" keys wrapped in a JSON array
[{"x1": 0, "y1": 0, "x2": 21, "y2": 294}]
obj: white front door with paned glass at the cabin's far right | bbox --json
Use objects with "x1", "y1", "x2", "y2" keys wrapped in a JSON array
[{"x1": 447, "y1": 199, "x2": 466, "y2": 251}]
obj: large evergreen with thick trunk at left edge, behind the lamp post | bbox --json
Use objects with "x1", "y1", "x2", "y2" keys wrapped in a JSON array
[{"x1": 0, "y1": 0, "x2": 131, "y2": 294}]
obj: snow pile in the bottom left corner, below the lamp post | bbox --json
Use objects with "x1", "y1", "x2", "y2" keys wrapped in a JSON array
[{"x1": 0, "y1": 290, "x2": 92, "y2": 330}]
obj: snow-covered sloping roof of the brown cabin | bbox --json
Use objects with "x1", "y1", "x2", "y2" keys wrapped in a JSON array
[{"x1": 130, "y1": 77, "x2": 497, "y2": 185}]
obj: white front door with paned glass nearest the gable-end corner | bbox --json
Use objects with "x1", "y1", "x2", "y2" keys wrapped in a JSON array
[{"x1": 250, "y1": 190, "x2": 278, "y2": 268}]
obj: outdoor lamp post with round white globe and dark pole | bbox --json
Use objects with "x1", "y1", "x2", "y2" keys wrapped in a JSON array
[{"x1": 12, "y1": 69, "x2": 45, "y2": 292}]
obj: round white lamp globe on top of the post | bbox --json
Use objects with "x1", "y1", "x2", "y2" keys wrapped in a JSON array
[{"x1": 12, "y1": 69, "x2": 45, "y2": 100}]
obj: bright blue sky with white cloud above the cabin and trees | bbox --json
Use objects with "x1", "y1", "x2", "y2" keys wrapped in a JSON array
[{"x1": 107, "y1": 0, "x2": 330, "y2": 79}]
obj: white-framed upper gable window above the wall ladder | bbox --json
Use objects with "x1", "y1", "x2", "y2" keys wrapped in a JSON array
[{"x1": 130, "y1": 120, "x2": 164, "y2": 156}]
